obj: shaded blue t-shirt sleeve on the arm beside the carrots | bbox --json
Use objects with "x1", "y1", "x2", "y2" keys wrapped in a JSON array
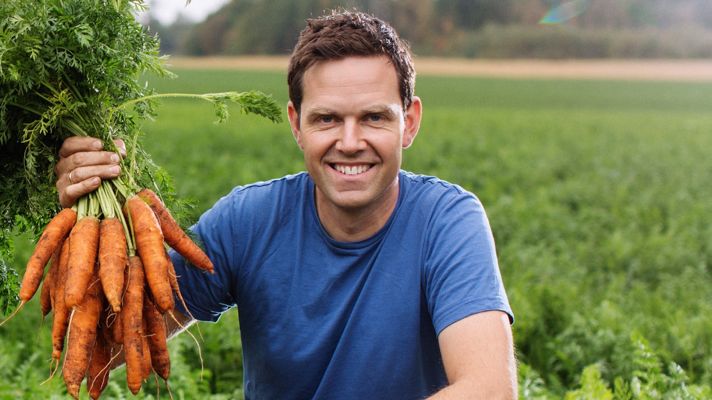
[{"x1": 169, "y1": 190, "x2": 237, "y2": 322}]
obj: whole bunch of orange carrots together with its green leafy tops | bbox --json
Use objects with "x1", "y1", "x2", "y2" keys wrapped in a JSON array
[{"x1": 0, "y1": 0, "x2": 281, "y2": 398}]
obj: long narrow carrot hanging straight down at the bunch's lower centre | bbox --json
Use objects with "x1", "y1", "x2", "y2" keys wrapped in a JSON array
[{"x1": 121, "y1": 256, "x2": 144, "y2": 394}]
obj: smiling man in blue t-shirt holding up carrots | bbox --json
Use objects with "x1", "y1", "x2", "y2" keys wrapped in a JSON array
[{"x1": 52, "y1": 12, "x2": 517, "y2": 399}]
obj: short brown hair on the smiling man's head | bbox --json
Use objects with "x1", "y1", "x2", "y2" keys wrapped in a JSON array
[{"x1": 287, "y1": 10, "x2": 415, "y2": 112}]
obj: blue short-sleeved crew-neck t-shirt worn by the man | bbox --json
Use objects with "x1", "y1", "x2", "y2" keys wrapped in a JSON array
[{"x1": 172, "y1": 171, "x2": 512, "y2": 399}]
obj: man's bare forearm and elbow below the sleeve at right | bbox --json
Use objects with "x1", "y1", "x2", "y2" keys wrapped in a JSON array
[{"x1": 430, "y1": 311, "x2": 517, "y2": 400}]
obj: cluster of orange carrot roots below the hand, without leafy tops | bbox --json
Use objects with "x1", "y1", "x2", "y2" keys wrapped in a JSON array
[{"x1": 4, "y1": 179, "x2": 213, "y2": 399}]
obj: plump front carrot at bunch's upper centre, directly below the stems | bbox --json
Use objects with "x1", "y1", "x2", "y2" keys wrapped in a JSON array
[{"x1": 99, "y1": 218, "x2": 128, "y2": 312}]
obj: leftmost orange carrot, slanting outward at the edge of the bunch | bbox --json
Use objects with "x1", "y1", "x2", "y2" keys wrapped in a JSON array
[{"x1": 20, "y1": 208, "x2": 77, "y2": 305}]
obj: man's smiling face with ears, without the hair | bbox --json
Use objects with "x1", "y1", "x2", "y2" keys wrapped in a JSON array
[{"x1": 288, "y1": 56, "x2": 421, "y2": 216}]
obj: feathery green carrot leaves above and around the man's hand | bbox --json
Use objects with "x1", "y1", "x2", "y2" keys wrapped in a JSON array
[{"x1": 0, "y1": 0, "x2": 280, "y2": 306}]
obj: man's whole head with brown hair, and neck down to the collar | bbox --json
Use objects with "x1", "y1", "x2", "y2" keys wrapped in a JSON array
[{"x1": 287, "y1": 8, "x2": 422, "y2": 240}]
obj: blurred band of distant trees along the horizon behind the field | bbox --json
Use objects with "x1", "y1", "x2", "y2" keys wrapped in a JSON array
[{"x1": 158, "y1": 0, "x2": 712, "y2": 58}]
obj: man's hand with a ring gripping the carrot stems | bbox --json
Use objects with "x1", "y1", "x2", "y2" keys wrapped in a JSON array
[{"x1": 54, "y1": 136, "x2": 126, "y2": 207}]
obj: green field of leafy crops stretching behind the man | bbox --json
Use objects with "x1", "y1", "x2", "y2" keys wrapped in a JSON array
[{"x1": 0, "y1": 70, "x2": 712, "y2": 399}]
